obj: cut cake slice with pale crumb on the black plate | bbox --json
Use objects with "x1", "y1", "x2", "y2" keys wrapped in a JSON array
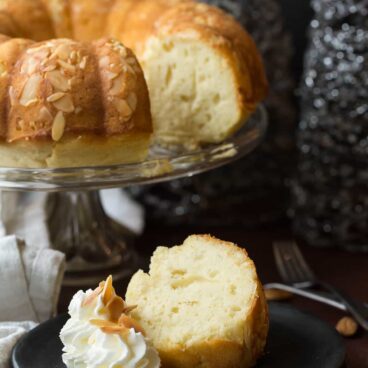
[{"x1": 126, "y1": 235, "x2": 268, "y2": 368}]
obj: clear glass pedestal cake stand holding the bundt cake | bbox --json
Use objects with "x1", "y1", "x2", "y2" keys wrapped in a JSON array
[{"x1": 0, "y1": 107, "x2": 267, "y2": 286}]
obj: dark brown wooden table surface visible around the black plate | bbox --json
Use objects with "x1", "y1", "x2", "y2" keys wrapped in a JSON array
[{"x1": 60, "y1": 223, "x2": 368, "y2": 368}]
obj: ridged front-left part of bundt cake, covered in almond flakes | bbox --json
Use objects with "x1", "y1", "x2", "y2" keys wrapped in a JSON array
[{"x1": 0, "y1": 36, "x2": 152, "y2": 167}]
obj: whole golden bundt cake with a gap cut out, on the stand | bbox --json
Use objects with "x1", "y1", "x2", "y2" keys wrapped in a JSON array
[{"x1": 0, "y1": 0, "x2": 267, "y2": 167}]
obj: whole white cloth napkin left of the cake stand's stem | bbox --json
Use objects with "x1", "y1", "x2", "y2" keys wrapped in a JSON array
[{"x1": 0, "y1": 192, "x2": 65, "y2": 368}]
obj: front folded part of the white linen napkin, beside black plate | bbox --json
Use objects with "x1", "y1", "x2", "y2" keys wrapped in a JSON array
[{"x1": 0, "y1": 235, "x2": 65, "y2": 368}]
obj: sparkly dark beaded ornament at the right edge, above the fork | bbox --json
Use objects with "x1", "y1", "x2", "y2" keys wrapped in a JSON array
[{"x1": 293, "y1": 0, "x2": 368, "y2": 251}]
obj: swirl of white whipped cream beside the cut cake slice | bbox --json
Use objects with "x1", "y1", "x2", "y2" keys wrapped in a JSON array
[{"x1": 60, "y1": 290, "x2": 160, "y2": 368}]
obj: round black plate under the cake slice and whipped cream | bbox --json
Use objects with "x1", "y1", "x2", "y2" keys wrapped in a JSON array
[{"x1": 12, "y1": 303, "x2": 345, "y2": 368}]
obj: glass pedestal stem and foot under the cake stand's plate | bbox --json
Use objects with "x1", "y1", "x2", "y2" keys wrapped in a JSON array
[{"x1": 47, "y1": 191, "x2": 140, "y2": 287}]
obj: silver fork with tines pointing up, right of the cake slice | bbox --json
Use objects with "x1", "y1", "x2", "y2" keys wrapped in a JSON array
[{"x1": 273, "y1": 241, "x2": 368, "y2": 331}]
